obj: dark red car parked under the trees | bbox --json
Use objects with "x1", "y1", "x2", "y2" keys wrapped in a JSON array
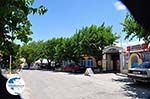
[{"x1": 63, "y1": 64, "x2": 81, "y2": 72}]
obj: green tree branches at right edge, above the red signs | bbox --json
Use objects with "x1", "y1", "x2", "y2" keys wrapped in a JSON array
[{"x1": 122, "y1": 14, "x2": 150, "y2": 43}]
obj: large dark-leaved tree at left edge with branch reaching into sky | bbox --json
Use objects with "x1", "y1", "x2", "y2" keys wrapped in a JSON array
[{"x1": 0, "y1": 0, "x2": 47, "y2": 68}]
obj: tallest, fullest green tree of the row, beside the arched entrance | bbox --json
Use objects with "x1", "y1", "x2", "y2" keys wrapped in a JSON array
[{"x1": 72, "y1": 23, "x2": 118, "y2": 64}]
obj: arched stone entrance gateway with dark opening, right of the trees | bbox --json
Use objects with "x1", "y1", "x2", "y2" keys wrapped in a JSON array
[{"x1": 102, "y1": 46, "x2": 126, "y2": 72}]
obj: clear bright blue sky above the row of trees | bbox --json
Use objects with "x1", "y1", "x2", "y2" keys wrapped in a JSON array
[{"x1": 29, "y1": 0, "x2": 131, "y2": 45}]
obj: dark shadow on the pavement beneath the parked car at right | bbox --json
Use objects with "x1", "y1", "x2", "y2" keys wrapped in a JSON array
[{"x1": 113, "y1": 77, "x2": 150, "y2": 99}]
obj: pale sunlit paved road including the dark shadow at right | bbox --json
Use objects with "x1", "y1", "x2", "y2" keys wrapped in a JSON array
[{"x1": 21, "y1": 70, "x2": 150, "y2": 99}]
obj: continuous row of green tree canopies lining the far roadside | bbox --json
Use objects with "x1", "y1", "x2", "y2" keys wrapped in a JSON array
[{"x1": 19, "y1": 23, "x2": 118, "y2": 66}]
